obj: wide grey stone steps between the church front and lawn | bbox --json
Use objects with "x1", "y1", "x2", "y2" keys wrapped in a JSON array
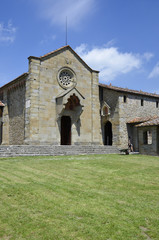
[{"x1": 0, "y1": 145, "x2": 119, "y2": 157}]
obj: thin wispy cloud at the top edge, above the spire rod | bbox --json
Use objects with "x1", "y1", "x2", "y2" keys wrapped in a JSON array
[{"x1": 34, "y1": 0, "x2": 95, "y2": 27}]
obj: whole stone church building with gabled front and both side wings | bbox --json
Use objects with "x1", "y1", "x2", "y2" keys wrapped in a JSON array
[{"x1": 0, "y1": 46, "x2": 159, "y2": 155}]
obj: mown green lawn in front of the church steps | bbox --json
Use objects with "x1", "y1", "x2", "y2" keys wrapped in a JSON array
[{"x1": 0, "y1": 155, "x2": 159, "y2": 240}]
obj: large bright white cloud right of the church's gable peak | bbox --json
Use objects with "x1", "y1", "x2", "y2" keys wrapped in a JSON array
[{"x1": 75, "y1": 44, "x2": 149, "y2": 82}]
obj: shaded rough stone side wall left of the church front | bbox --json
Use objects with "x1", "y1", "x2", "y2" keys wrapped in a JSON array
[{"x1": 7, "y1": 85, "x2": 25, "y2": 145}]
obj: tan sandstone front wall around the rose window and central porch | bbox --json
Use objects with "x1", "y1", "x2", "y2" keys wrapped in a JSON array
[{"x1": 25, "y1": 49, "x2": 100, "y2": 145}]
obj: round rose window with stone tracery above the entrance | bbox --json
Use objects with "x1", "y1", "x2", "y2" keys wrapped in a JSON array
[{"x1": 58, "y1": 68, "x2": 76, "y2": 89}]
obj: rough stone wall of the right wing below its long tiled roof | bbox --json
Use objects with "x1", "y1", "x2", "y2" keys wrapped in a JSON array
[{"x1": 103, "y1": 88, "x2": 159, "y2": 147}]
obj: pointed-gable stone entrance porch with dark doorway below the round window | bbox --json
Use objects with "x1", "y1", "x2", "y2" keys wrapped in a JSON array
[{"x1": 56, "y1": 88, "x2": 84, "y2": 145}]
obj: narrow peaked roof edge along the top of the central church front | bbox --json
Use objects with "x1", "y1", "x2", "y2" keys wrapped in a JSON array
[{"x1": 28, "y1": 45, "x2": 99, "y2": 73}]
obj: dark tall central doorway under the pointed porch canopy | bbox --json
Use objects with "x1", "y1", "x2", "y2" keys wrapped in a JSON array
[{"x1": 61, "y1": 116, "x2": 71, "y2": 145}]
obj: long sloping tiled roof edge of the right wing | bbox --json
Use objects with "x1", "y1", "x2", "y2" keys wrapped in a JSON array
[{"x1": 99, "y1": 83, "x2": 159, "y2": 98}]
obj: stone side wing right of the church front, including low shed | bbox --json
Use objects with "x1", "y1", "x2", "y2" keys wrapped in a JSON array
[{"x1": 99, "y1": 84, "x2": 159, "y2": 155}]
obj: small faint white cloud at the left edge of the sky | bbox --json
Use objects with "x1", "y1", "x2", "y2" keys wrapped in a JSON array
[{"x1": 0, "y1": 21, "x2": 16, "y2": 43}]
